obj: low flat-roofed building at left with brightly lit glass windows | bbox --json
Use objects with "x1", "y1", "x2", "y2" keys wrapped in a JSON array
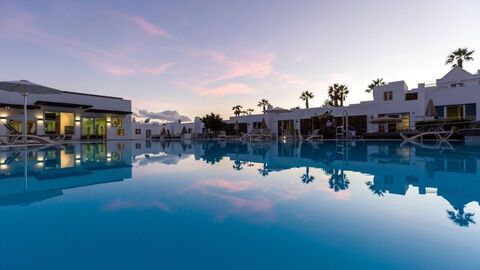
[{"x1": 0, "y1": 91, "x2": 132, "y2": 140}]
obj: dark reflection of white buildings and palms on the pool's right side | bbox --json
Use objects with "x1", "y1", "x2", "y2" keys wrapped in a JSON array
[{"x1": 155, "y1": 142, "x2": 480, "y2": 225}]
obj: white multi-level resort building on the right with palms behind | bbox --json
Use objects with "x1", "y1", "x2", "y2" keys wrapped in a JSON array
[{"x1": 227, "y1": 66, "x2": 480, "y2": 138}]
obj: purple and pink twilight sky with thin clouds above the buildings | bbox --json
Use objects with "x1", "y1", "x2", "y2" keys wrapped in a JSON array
[{"x1": 0, "y1": 0, "x2": 480, "y2": 120}]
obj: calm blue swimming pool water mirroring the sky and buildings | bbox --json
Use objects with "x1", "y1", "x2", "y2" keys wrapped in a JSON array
[{"x1": 0, "y1": 141, "x2": 480, "y2": 269}]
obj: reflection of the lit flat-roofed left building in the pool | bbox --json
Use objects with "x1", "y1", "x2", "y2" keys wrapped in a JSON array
[{"x1": 0, "y1": 144, "x2": 132, "y2": 205}]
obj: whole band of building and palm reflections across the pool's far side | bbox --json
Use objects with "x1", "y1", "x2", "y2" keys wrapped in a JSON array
[{"x1": 0, "y1": 141, "x2": 480, "y2": 227}]
